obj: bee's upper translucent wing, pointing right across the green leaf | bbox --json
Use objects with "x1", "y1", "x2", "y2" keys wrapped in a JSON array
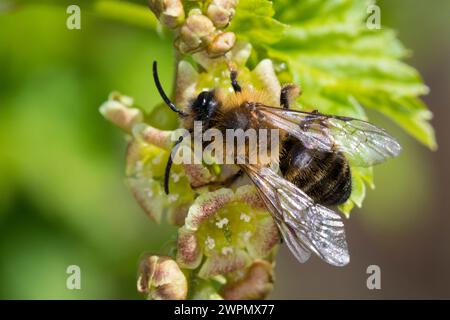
[{"x1": 258, "y1": 105, "x2": 401, "y2": 167}]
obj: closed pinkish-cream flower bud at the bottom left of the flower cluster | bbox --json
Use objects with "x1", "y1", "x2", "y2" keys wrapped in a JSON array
[{"x1": 137, "y1": 256, "x2": 188, "y2": 300}]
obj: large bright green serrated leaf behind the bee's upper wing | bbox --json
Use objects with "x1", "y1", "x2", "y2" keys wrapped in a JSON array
[{"x1": 264, "y1": 0, "x2": 437, "y2": 216}]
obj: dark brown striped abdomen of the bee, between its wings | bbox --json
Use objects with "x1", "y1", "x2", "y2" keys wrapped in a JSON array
[{"x1": 280, "y1": 138, "x2": 352, "y2": 205}]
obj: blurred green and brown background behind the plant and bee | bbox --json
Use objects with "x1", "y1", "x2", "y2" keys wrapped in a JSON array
[{"x1": 0, "y1": 0, "x2": 450, "y2": 299}]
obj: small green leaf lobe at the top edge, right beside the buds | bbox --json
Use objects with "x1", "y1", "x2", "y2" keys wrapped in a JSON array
[{"x1": 230, "y1": 0, "x2": 286, "y2": 46}]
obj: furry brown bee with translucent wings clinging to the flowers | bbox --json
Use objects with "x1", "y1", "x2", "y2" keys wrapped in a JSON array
[{"x1": 153, "y1": 62, "x2": 401, "y2": 266}]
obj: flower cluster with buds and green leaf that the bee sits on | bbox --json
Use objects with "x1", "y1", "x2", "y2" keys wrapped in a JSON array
[{"x1": 100, "y1": 0, "x2": 435, "y2": 299}]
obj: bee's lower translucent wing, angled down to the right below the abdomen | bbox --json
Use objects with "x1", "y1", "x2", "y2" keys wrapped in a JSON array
[{"x1": 243, "y1": 165, "x2": 350, "y2": 266}]
